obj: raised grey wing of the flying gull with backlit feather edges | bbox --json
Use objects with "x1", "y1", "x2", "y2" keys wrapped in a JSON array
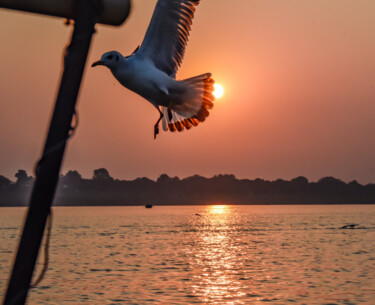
[{"x1": 137, "y1": 0, "x2": 199, "y2": 77}]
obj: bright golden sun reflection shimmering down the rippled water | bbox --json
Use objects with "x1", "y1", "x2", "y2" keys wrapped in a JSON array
[{"x1": 192, "y1": 205, "x2": 245, "y2": 304}]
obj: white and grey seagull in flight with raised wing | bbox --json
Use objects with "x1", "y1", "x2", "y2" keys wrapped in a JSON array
[{"x1": 92, "y1": 0, "x2": 215, "y2": 139}]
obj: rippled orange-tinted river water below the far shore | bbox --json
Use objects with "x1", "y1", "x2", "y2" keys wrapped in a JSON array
[{"x1": 0, "y1": 205, "x2": 375, "y2": 305}]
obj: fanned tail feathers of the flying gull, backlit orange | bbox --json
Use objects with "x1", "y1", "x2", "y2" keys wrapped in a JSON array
[{"x1": 161, "y1": 73, "x2": 215, "y2": 132}]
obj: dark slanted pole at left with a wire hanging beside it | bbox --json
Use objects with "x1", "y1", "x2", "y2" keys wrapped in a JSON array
[{"x1": 4, "y1": 0, "x2": 99, "y2": 305}]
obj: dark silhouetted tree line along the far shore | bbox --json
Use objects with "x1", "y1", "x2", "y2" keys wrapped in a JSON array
[{"x1": 0, "y1": 168, "x2": 375, "y2": 206}]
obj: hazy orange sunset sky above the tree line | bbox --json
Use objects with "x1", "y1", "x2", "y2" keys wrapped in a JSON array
[{"x1": 0, "y1": 0, "x2": 375, "y2": 183}]
